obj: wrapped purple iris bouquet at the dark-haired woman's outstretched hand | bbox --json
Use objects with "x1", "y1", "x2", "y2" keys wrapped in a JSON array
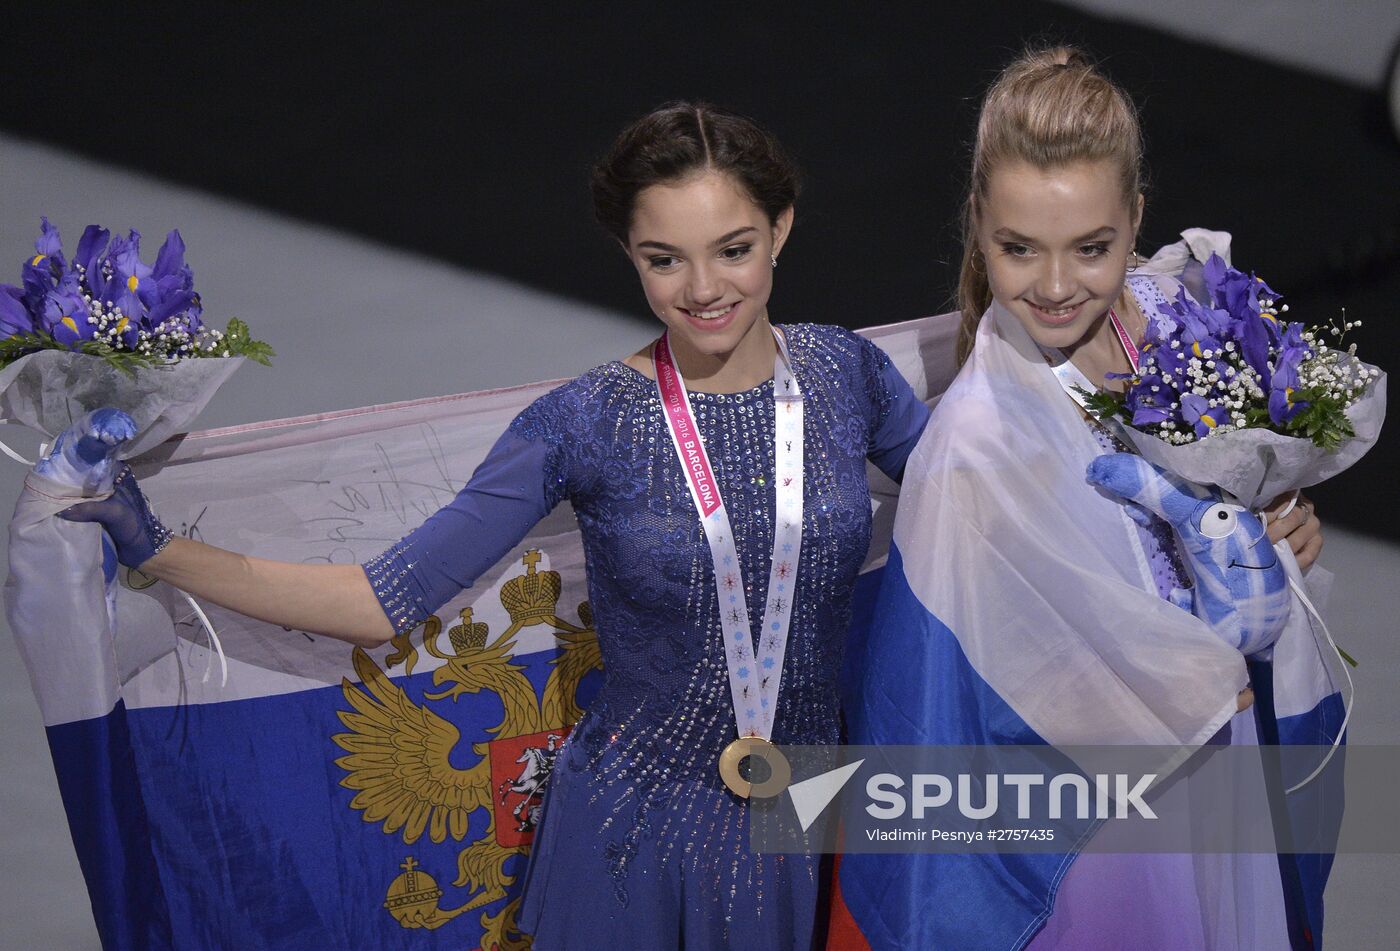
[{"x1": 0, "y1": 218, "x2": 273, "y2": 458}]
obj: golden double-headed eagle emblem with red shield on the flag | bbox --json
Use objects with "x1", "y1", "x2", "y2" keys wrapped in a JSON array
[{"x1": 333, "y1": 550, "x2": 602, "y2": 951}]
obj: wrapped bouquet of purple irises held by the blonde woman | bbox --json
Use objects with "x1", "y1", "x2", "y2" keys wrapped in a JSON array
[{"x1": 1089, "y1": 230, "x2": 1386, "y2": 510}]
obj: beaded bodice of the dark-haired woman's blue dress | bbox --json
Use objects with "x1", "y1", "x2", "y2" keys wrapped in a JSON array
[{"x1": 512, "y1": 326, "x2": 886, "y2": 767}]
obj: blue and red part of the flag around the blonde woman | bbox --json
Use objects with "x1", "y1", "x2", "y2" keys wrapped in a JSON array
[{"x1": 827, "y1": 546, "x2": 1344, "y2": 951}]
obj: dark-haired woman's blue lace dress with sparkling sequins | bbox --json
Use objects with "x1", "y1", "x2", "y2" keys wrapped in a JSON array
[{"x1": 365, "y1": 325, "x2": 928, "y2": 950}]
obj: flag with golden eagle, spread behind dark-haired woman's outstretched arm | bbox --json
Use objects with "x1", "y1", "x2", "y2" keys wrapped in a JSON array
[{"x1": 7, "y1": 384, "x2": 601, "y2": 951}]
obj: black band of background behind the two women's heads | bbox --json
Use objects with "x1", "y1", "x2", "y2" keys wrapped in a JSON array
[{"x1": 0, "y1": 0, "x2": 1400, "y2": 538}]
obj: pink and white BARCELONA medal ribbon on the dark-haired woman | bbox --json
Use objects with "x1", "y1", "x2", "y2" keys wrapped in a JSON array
[{"x1": 651, "y1": 329, "x2": 802, "y2": 740}]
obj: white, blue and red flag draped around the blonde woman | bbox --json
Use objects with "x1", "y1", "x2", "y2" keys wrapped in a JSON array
[{"x1": 829, "y1": 308, "x2": 1343, "y2": 951}]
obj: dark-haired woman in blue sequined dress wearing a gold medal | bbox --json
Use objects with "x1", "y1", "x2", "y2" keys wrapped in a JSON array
[{"x1": 71, "y1": 104, "x2": 927, "y2": 951}]
